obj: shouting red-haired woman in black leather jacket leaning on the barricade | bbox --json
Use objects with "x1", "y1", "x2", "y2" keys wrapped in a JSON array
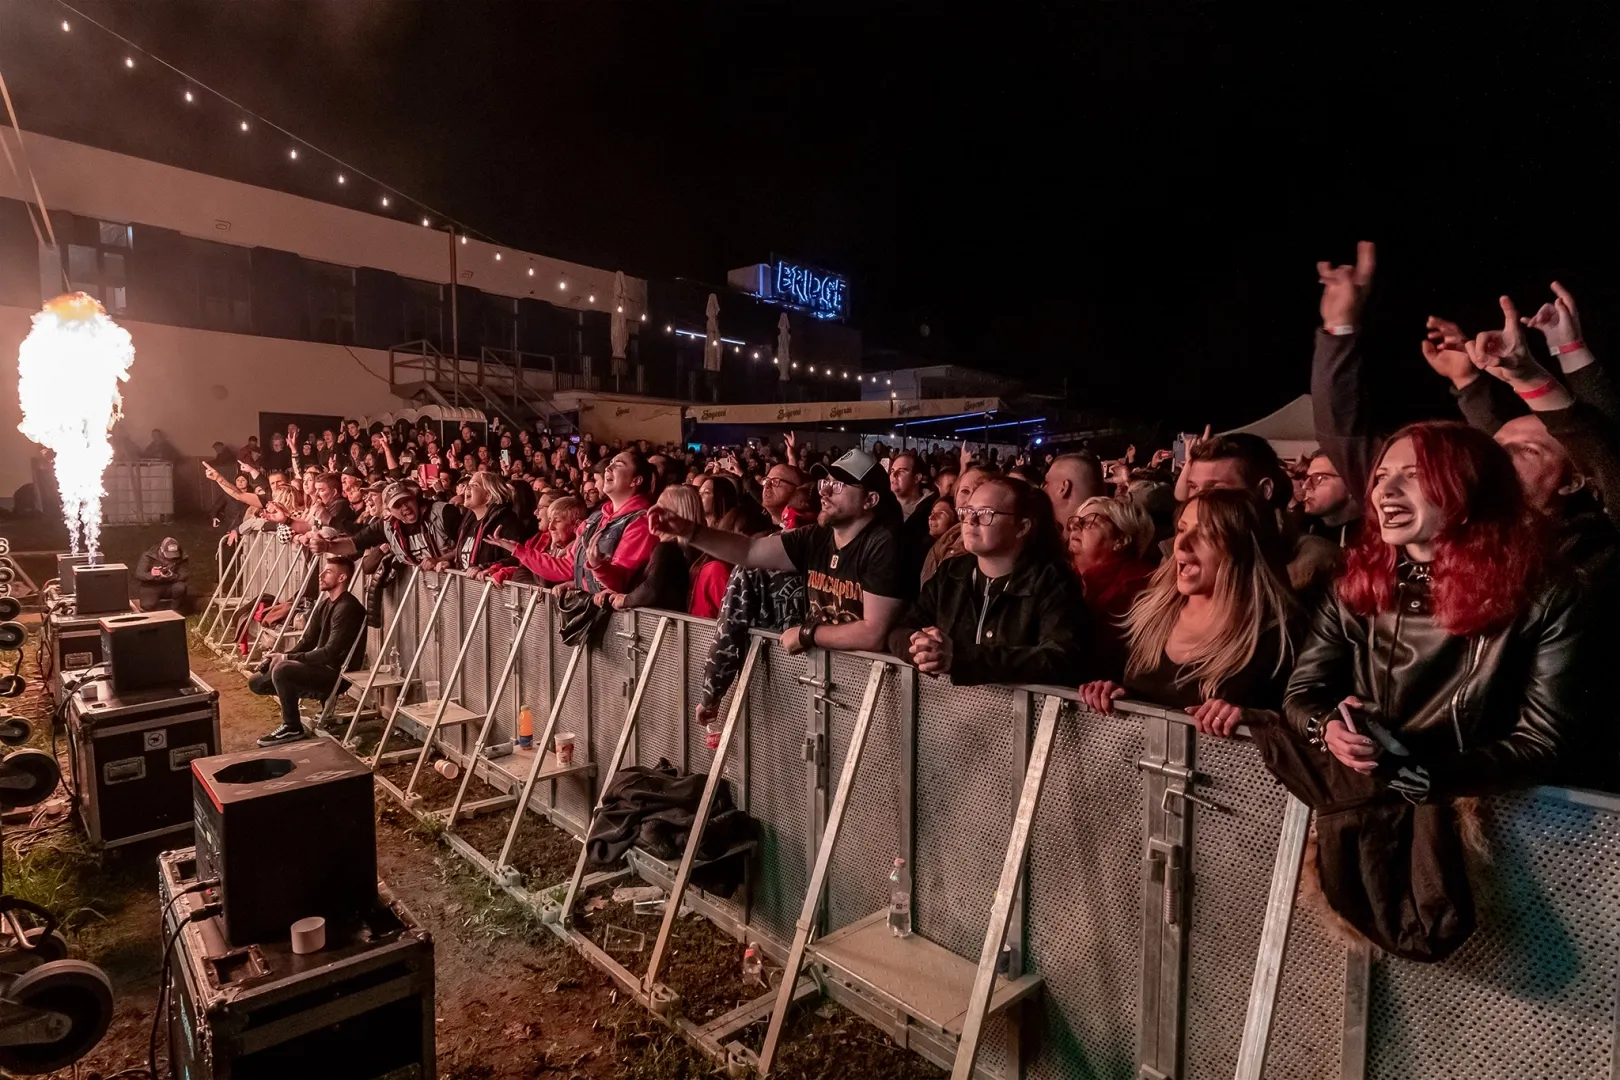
[{"x1": 1285, "y1": 423, "x2": 1581, "y2": 798}]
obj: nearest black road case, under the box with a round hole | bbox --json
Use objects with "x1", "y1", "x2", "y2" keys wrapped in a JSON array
[{"x1": 157, "y1": 848, "x2": 437, "y2": 1080}]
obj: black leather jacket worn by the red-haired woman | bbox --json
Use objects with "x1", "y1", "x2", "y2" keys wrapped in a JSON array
[{"x1": 1283, "y1": 559, "x2": 1591, "y2": 797}]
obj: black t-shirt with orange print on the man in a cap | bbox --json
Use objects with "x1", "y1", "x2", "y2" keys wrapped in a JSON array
[{"x1": 782, "y1": 523, "x2": 917, "y2": 625}]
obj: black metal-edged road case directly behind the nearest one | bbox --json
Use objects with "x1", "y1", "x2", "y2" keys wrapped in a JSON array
[{"x1": 66, "y1": 675, "x2": 219, "y2": 847}]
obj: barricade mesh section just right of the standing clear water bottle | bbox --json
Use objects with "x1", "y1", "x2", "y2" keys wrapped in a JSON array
[{"x1": 913, "y1": 675, "x2": 1022, "y2": 960}]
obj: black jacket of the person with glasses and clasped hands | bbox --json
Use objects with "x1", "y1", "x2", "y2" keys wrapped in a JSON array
[{"x1": 889, "y1": 555, "x2": 1090, "y2": 687}]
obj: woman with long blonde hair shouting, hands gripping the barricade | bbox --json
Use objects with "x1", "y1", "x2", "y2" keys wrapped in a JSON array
[{"x1": 1081, "y1": 491, "x2": 1294, "y2": 735}]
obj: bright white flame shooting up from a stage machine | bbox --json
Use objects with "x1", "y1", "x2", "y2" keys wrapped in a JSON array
[{"x1": 16, "y1": 293, "x2": 134, "y2": 557}]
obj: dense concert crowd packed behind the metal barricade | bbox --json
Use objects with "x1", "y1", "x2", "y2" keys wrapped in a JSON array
[{"x1": 211, "y1": 244, "x2": 1620, "y2": 959}]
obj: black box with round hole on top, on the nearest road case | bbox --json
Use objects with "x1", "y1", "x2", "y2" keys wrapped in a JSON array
[{"x1": 191, "y1": 738, "x2": 377, "y2": 946}]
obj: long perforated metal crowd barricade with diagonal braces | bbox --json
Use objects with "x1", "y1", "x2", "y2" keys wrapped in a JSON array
[{"x1": 358, "y1": 566, "x2": 1620, "y2": 1080}]
